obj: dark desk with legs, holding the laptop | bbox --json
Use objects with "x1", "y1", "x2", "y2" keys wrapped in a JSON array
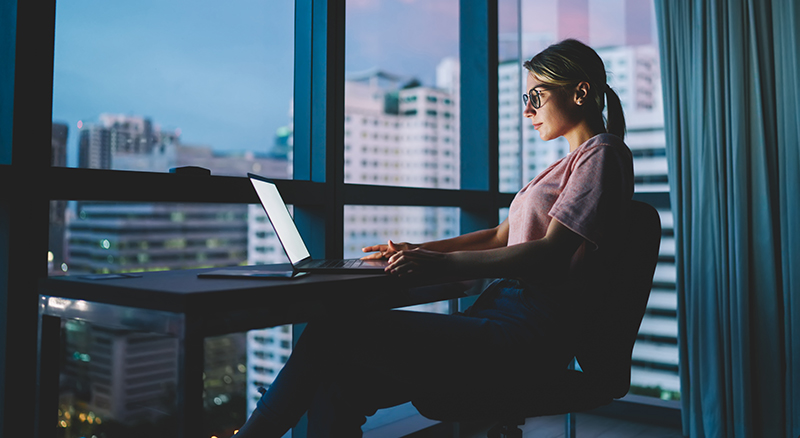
[{"x1": 36, "y1": 265, "x2": 465, "y2": 437}]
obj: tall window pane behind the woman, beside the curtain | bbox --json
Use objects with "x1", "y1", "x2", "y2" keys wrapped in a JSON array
[{"x1": 498, "y1": 0, "x2": 680, "y2": 399}]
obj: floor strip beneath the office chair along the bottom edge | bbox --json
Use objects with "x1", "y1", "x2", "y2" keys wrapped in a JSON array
[{"x1": 465, "y1": 414, "x2": 683, "y2": 438}]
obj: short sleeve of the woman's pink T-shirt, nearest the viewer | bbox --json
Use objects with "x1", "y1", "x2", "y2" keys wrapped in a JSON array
[{"x1": 549, "y1": 134, "x2": 633, "y2": 249}]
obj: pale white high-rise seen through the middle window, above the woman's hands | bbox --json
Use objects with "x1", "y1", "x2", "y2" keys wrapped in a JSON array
[{"x1": 344, "y1": 64, "x2": 460, "y2": 257}]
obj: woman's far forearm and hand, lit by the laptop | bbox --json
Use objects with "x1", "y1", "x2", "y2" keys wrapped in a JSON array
[{"x1": 361, "y1": 219, "x2": 508, "y2": 259}]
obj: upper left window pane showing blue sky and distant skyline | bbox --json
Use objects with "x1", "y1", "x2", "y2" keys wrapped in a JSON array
[{"x1": 53, "y1": 0, "x2": 294, "y2": 178}]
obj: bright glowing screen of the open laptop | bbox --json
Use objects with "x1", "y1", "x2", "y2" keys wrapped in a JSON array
[{"x1": 250, "y1": 177, "x2": 311, "y2": 264}]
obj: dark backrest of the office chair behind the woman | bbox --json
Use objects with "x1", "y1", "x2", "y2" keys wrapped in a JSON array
[{"x1": 575, "y1": 201, "x2": 661, "y2": 398}]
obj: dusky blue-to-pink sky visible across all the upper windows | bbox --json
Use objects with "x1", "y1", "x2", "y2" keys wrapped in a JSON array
[{"x1": 53, "y1": 0, "x2": 648, "y2": 166}]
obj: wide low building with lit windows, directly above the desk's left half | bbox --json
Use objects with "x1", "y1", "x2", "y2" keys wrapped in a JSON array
[{"x1": 68, "y1": 202, "x2": 247, "y2": 273}]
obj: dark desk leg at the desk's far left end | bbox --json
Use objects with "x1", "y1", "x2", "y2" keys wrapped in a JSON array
[{"x1": 34, "y1": 314, "x2": 61, "y2": 438}]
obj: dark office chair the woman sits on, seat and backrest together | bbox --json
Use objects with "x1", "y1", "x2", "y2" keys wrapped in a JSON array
[{"x1": 414, "y1": 201, "x2": 661, "y2": 438}]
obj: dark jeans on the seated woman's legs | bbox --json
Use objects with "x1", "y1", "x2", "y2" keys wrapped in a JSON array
[{"x1": 258, "y1": 280, "x2": 566, "y2": 437}]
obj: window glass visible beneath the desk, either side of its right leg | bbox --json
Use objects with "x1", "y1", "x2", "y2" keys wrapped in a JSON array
[{"x1": 58, "y1": 320, "x2": 292, "y2": 438}]
